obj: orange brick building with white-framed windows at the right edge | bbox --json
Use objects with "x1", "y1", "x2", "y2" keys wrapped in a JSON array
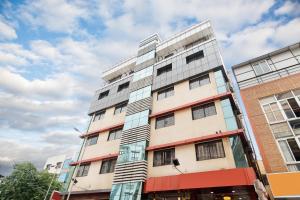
[{"x1": 233, "y1": 43, "x2": 300, "y2": 199}]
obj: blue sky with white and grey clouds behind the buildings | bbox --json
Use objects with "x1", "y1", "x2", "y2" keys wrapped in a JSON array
[{"x1": 0, "y1": 0, "x2": 300, "y2": 175}]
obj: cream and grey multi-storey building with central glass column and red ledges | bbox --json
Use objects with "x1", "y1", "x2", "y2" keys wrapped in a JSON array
[{"x1": 65, "y1": 21, "x2": 256, "y2": 200}]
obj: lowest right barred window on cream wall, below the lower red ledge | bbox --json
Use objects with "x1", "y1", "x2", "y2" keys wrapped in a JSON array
[{"x1": 196, "y1": 140, "x2": 225, "y2": 161}]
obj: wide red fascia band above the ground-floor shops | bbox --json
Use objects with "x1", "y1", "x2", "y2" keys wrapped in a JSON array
[{"x1": 144, "y1": 167, "x2": 256, "y2": 193}]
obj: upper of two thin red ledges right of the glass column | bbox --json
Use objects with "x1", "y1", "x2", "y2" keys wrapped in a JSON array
[{"x1": 149, "y1": 92, "x2": 232, "y2": 118}]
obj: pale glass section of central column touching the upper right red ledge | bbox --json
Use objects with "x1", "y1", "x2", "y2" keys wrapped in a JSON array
[{"x1": 124, "y1": 110, "x2": 149, "y2": 130}]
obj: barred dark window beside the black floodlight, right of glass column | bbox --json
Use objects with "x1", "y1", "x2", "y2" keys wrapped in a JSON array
[{"x1": 153, "y1": 148, "x2": 175, "y2": 167}]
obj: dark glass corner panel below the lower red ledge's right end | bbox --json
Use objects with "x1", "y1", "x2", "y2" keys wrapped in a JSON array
[{"x1": 229, "y1": 136, "x2": 248, "y2": 167}]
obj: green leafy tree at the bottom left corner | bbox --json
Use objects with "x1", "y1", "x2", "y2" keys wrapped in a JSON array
[{"x1": 0, "y1": 162, "x2": 61, "y2": 200}]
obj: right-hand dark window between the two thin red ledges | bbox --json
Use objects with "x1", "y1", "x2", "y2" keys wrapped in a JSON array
[{"x1": 192, "y1": 103, "x2": 217, "y2": 120}]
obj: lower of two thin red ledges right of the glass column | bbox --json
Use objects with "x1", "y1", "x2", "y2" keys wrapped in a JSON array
[{"x1": 146, "y1": 129, "x2": 244, "y2": 151}]
